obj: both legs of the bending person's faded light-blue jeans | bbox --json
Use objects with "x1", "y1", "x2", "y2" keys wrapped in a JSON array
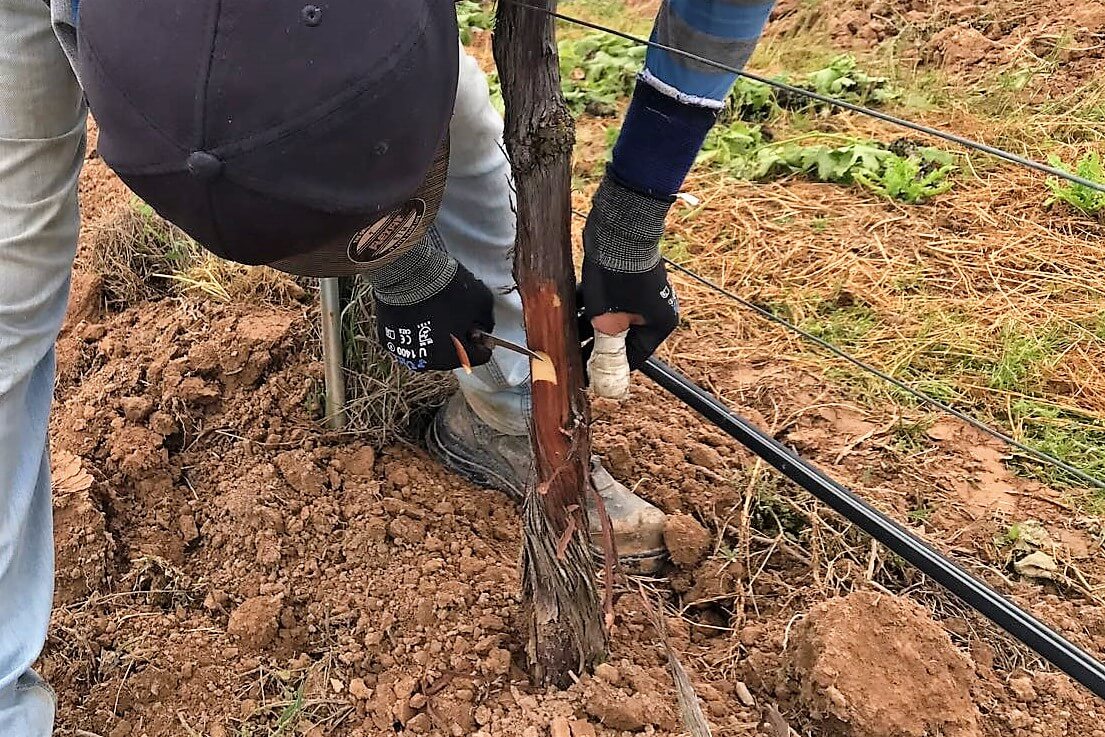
[{"x1": 0, "y1": 0, "x2": 529, "y2": 737}]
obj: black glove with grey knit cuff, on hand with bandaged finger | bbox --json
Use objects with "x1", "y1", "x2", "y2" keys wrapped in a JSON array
[{"x1": 580, "y1": 172, "x2": 678, "y2": 369}]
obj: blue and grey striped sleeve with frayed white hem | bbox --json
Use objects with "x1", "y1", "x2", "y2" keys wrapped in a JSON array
[{"x1": 641, "y1": 0, "x2": 775, "y2": 108}]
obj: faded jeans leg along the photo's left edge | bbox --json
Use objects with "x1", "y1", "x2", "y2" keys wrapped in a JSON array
[{"x1": 0, "y1": 0, "x2": 84, "y2": 737}]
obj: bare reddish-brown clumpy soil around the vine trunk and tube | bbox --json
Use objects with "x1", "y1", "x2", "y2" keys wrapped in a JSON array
[{"x1": 39, "y1": 0, "x2": 1105, "y2": 737}]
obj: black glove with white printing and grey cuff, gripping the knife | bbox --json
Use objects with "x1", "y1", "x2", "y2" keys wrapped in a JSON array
[{"x1": 368, "y1": 229, "x2": 495, "y2": 371}]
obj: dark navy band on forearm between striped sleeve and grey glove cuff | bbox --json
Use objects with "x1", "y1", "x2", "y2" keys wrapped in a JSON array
[{"x1": 610, "y1": 80, "x2": 717, "y2": 199}]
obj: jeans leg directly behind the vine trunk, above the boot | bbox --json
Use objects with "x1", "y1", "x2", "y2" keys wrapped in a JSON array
[{"x1": 436, "y1": 48, "x2": 529, "y2": 435}]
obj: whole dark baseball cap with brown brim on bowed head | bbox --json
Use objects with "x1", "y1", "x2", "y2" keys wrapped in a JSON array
[{"x1": 77, "y1": 0, "x2": 459, "y2": 276}]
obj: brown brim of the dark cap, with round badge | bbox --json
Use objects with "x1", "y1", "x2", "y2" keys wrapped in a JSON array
[{"x1": 269, "y1": 135, "x2": 449, "y2": 278}]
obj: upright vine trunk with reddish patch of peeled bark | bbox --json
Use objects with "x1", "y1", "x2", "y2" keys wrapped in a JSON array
[{"x1": 494, "y1": 0, "x2": 607, "y2": 686}]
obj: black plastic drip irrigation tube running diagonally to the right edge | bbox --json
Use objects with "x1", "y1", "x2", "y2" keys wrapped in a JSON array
[{"x1": 641, "y1": 358, "x2": 1105, "y2": 698}]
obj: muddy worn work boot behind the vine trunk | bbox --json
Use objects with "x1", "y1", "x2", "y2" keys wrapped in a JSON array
[{"x1": 427, "y1": 392, "x2": 665, "y2": 573}]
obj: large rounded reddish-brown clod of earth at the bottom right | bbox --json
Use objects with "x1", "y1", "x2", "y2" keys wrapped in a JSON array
[{"x1": 789, "y1": 591, "x2": 981, "y2": 737}]
